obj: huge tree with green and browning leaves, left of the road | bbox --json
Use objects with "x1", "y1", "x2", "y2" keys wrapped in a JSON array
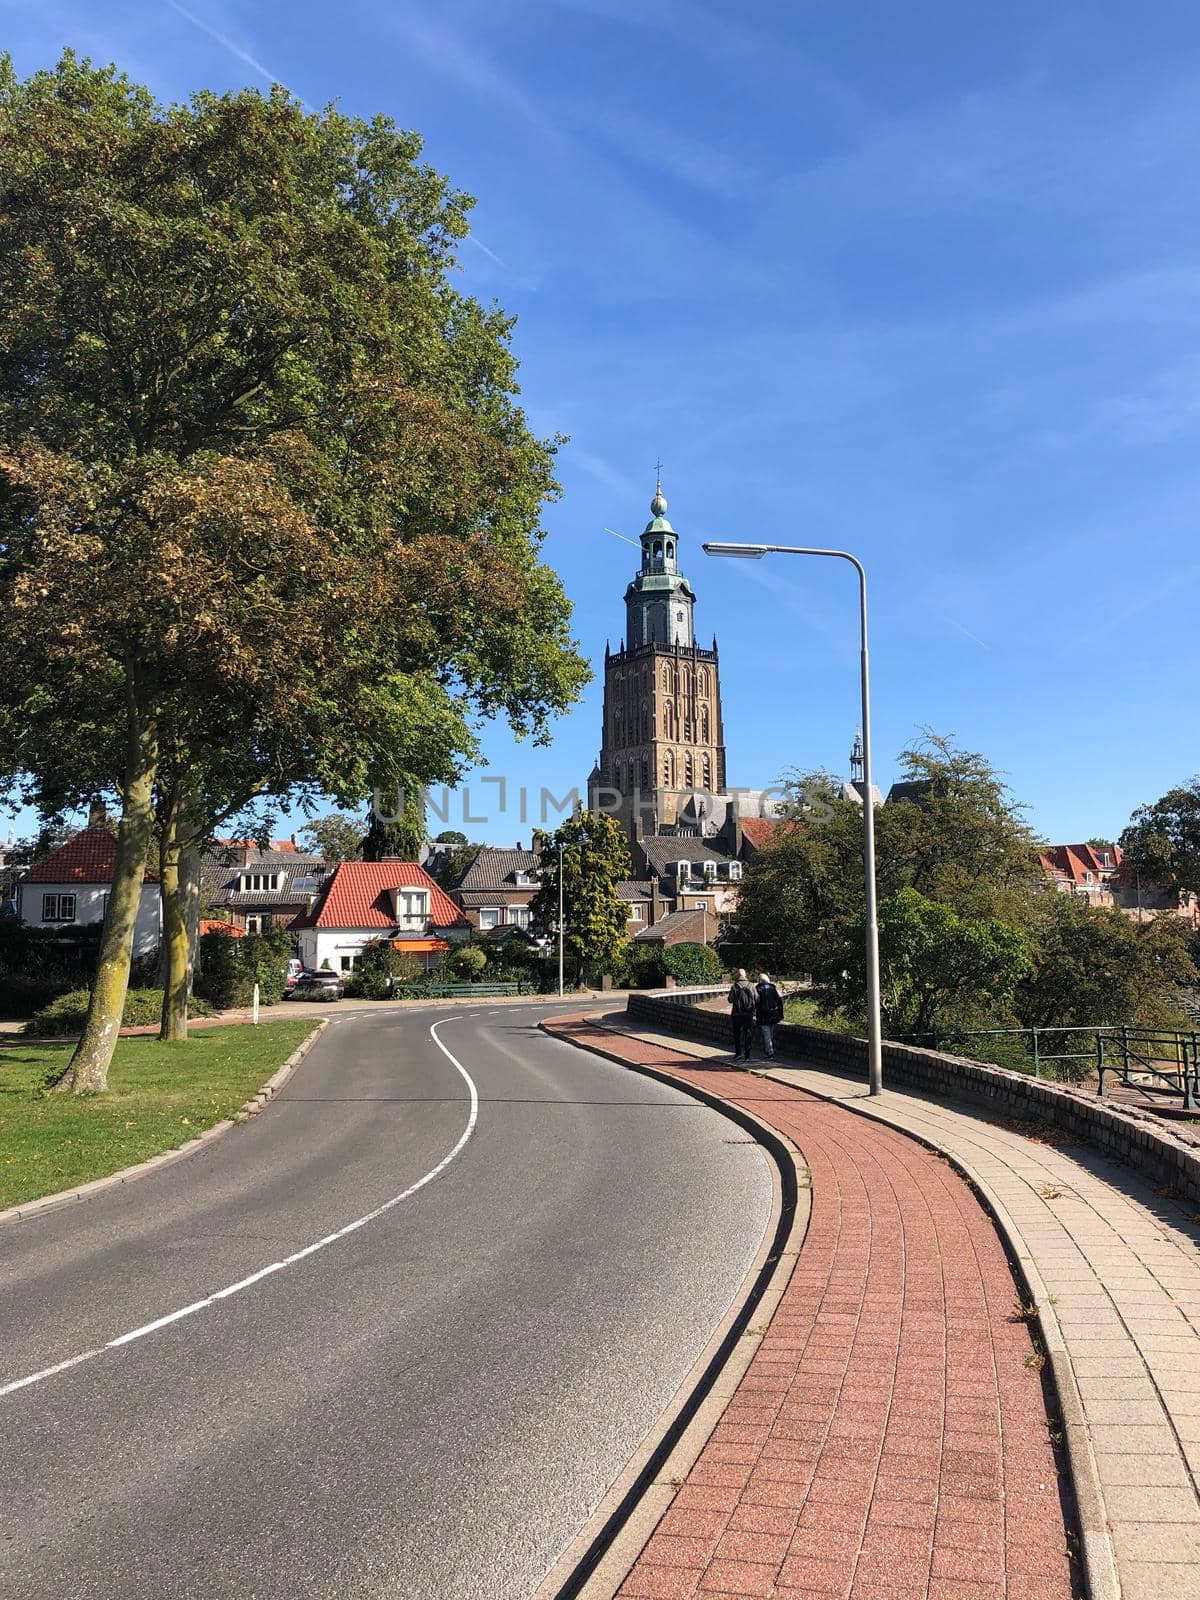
[{"x1": 0, "y1": 54, "x2": 586, "y2": 1090}]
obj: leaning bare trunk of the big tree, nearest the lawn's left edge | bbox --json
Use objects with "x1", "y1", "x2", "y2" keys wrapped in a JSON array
[{"x1": 56, "y1": 707, "x2": 157, "y2": 1094}]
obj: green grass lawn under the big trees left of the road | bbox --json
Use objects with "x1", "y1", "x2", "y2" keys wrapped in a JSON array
[{"x1": 0, "y1": 1018, "x2": 315, "y2": 1210}]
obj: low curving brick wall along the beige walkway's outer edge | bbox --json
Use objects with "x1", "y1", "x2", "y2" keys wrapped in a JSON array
[{"x1": 626, "y1": 989, "x2": 1200, "y2": 1205}]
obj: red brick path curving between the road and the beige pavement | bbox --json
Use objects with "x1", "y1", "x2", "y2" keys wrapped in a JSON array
[{"x1": 549, "y1": 1019, "x2": 1074, "y2": 1600}]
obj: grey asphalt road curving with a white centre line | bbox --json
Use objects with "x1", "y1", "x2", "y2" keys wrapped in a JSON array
[{"x1": 0, "y1": 1006, "x2": 770, "y2": 1600}]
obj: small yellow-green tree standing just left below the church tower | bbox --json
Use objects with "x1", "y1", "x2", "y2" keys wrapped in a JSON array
[{"x1": 531, "y1": 811, "x2": 630, "y2": 987}]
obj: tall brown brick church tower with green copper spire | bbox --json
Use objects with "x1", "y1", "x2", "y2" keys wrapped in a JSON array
[{"x1": 590, "y1": 482, "x2": 725, "y2": 840}]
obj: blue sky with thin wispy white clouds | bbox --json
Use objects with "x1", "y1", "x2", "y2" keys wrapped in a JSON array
[{"x1": 0, "y1": 0, "x2": 1200, "y2": 842}]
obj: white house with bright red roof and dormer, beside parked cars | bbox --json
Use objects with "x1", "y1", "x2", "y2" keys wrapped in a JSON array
[{"x1": 291, "y1": 861, "x2": 469, "y2": 973}]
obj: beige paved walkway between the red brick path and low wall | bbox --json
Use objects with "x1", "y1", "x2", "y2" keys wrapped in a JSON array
[{"x1": 604, "y1": 1032, "x2": 1200, "y2": 1600}]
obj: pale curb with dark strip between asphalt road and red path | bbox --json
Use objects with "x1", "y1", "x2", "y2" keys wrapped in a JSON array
[{"x1": 531, "y1": 1019, "x2": 811, "y2": 1600}]
